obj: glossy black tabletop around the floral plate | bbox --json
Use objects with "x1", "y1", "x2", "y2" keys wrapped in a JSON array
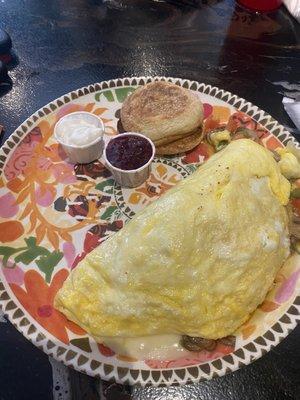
[{"x1": 0, "y1": 0, "x2": 300, "y2": 400}]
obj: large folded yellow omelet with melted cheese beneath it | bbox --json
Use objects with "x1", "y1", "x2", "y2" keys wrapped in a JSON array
[{"x1": 55, "y1": 139, "x2": 290, "y2": 339}]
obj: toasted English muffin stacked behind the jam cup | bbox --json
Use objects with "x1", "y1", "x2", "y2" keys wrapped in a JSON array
[{"x1": 121, "y1": 81, "x2": 203, "y2": 154}]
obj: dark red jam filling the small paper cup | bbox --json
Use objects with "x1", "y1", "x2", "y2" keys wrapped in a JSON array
[{"x1": 106, "y1": 135, "x2": 153, "y2": 171}]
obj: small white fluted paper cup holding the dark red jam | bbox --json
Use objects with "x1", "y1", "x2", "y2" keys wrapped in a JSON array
[{"x1": 103, "y1": 132, "x2": 155, "y2": 188}]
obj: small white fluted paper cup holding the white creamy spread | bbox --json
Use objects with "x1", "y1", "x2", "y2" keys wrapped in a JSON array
[{"x1": 54, "y1": 111, "x2": 105, "y2": 164}]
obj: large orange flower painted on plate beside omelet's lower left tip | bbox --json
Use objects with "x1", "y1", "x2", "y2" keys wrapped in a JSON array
[{"x1": 10, "y1": 269, "x2": 85, "y2": 343}]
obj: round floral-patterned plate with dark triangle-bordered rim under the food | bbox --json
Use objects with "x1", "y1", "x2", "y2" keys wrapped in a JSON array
[{"x1": 0, "y1": 77, "x2": 300, "y2": 386}]
